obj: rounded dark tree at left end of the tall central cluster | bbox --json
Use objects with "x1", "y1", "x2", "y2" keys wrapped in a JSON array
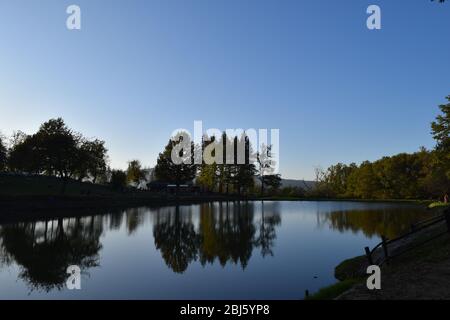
[{"x1": 155, "y1": 137, "x2": 197, "y2": 188}]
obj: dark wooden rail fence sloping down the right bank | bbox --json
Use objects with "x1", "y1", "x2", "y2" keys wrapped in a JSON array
[{"x1": 364, "y1": 208, "x2": 450, "y2": 266}]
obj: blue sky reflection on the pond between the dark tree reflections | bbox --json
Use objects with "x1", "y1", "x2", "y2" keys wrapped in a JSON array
[{"x1": 0, "y1": 202, "x2": 428, "y2": 299}]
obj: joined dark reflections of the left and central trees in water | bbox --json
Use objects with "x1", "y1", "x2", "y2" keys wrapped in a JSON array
[{"x1": 0, "y1": 202, "x2": 281, "y2": 292}]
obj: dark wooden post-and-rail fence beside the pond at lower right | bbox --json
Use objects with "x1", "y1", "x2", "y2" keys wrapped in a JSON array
[{"x1": 365, "y1": 208, "x2": 450, "y2": 266}]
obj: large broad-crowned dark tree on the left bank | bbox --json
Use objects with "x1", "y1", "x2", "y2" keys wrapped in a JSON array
[{"x1": 8, "y1": 118, "x2": 108, "y2": 193}]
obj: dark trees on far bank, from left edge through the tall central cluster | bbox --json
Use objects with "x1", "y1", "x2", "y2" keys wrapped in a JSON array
[{"x1": 0, "y1": 118, "x2": 281, "y2": 194}]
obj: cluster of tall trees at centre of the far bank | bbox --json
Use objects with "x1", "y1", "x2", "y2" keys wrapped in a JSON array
[{"x1": 155, "y1": 132, "x2": 281, "y2": 195}]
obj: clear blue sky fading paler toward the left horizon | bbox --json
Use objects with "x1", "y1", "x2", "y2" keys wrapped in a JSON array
[{"x1": 0, "y1": 0, "x2": 450, "y2": 179}]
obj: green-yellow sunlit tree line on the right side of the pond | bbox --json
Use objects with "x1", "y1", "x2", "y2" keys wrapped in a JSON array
[{"x1": 314, "y1": 96, "x2": 450, "y2": 199}]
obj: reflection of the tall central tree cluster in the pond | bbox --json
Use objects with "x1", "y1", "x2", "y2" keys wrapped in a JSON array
[{"x1": 153, "y1": 202, "x2": 281, "y2": 273}]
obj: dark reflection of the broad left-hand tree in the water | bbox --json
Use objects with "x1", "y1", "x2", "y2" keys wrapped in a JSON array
[{"x1": 0, "y1": 217, "x2": 103, "y2": 292}]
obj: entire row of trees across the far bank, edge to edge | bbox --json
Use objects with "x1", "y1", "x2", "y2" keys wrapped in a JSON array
[{"x1": 0, "y1": 96, "x2": 450, "y2": 199}]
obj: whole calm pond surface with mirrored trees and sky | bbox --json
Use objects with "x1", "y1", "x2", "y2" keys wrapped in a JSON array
[{"x1": 0, "y1": 202, "x2": 429, "y2": 299}]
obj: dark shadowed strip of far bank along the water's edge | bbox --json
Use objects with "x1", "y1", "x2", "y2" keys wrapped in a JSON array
[{"x1": 0, "y1": 193, "x2": 432, "y2": 222}]
